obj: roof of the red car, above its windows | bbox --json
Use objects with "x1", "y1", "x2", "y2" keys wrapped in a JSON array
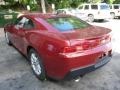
[{"x1": 23, "y1": 13, "x2": 71, "y2": 19}]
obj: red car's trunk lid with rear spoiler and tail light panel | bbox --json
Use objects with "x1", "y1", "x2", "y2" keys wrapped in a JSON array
[{"x1": 63, "y1": 26, "x2": 111, "y2": 52}]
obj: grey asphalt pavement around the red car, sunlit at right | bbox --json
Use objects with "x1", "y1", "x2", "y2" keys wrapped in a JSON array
[{"x1": 0, "y1": 19, "x2": 120, "y2": 90}]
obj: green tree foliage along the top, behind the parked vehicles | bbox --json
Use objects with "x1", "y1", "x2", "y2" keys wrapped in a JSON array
[{"x1": 4, "y1": 0, "x2": 116, "y2": 11}]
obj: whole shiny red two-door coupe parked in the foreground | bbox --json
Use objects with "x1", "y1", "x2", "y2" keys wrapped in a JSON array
[{"x1": 4, "y1": 14, "x2": 112, "y2": 80}]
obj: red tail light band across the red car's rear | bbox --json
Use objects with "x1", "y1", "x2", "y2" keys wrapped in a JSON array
[{"x1": 62, "y1": 35, "x2": 111, "y2": 53}]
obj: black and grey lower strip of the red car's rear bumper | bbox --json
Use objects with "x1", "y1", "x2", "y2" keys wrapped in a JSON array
[{"x1": 64, "y1": 56, "x2": 111, "y2": 80}]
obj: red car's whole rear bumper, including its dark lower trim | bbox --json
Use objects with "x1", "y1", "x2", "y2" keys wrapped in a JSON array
[{"x1": 46, "y1": 43, "x2": 112, "y2": 80}]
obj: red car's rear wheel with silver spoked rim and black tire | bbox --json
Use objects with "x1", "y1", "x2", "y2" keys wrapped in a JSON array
[{"x1": 28, "y1": 49, "x2": 46, "y2": 81}]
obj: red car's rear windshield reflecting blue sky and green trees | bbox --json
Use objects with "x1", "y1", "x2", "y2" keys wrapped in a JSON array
[{"x1": 47, "y1": 17, "x2": 89, "y2": 32}]
